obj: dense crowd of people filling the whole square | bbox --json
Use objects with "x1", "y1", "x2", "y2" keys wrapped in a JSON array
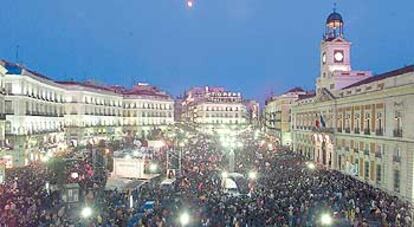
[{"x1": 0, "y1": 127, "x2": 412, "y2": 227}]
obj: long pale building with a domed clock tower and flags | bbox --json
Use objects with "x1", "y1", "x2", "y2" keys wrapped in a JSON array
[{"x1": 291, "y1": 9, "x2": 414, "y2": 201}]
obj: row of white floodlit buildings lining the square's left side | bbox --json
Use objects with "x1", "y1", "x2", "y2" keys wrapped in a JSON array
[{"x1": 0, "y1": 61, "x2": 174, "y2": 167}]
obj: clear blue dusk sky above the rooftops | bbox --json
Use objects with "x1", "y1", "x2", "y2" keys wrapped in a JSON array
[{"x1": 0, "y1": 0, "x2": 414, "y2": 101}]
